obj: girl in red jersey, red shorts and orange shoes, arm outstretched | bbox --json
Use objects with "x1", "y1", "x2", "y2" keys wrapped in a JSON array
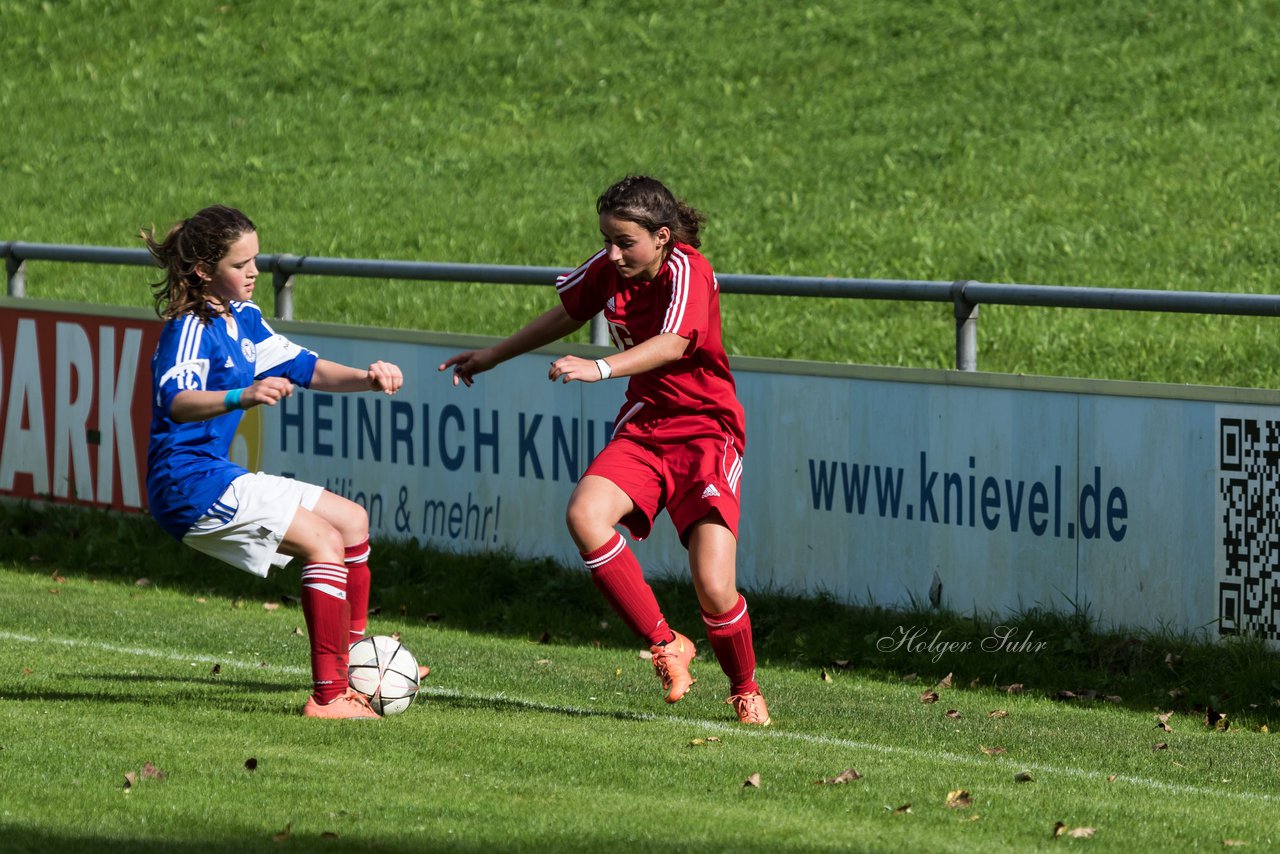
[{"x1": 440, "y1": 175, "x2": 771, "y2": 726}]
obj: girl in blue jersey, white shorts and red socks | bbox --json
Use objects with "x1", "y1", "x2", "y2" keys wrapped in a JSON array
[{"x1": 142, "y1": 205, "x2": 414, "y2": 718}]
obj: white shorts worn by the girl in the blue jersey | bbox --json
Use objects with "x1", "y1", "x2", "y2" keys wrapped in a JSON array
[{"x1": 182, "y1": 471, "x2": 324, "y2": 579}]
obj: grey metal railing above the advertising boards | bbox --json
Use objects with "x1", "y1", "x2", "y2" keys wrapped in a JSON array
[{"x1": 0, "y1": 242, "x2": 1280, "y2": 371}]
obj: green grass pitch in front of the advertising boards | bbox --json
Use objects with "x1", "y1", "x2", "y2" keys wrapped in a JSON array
[{"x1": 0, "y1": 504, "x2": 1280, "y2": 851}]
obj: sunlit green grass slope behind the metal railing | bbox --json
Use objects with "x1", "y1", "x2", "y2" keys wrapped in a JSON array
[{"x1": 0, "y1": 0, "x2": 1280, "y2": 387}]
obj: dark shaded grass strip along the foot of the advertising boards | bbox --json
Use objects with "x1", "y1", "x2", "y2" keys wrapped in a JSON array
[{"x1": 0, "y1": 502, "x2": 1280, "y2": 727}]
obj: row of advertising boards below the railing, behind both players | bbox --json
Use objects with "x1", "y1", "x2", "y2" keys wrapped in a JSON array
[{"x1": 0, "y1": 301, "x2": 1280, "y2": 639}]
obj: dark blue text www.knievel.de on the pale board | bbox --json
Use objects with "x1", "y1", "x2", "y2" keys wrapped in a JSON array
[{"x1": 809, "y1": 451, "x2": 1129, "y2": 543}]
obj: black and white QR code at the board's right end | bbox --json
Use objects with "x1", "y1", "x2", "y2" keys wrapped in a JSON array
[{"x1": 1217, "y1": 417, "x2": 1280, "y2": 641}]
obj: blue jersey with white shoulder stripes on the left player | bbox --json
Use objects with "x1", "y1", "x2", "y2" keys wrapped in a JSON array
[{"x1": 147, "y1": 302, "x2": 317, "y2": 540}]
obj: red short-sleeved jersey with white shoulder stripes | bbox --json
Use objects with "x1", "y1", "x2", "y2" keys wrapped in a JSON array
[{"x1": 556, "y1": 243, "x2": 746, "y2": 452}]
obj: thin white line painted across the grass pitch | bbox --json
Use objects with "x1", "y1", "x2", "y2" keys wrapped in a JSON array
[{"x1": 0, "y1": 631, "x2": 1280, "y2": 803}]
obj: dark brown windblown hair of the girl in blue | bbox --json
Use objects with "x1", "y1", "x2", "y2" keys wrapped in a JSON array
[{"x1": 138, "y1": 205, "x2": 257, "y2": 324}]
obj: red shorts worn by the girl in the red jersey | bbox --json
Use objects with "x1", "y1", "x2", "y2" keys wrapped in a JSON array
[{"x1": 584, "y1": 415, "x2": 742, "y2": 547}]
